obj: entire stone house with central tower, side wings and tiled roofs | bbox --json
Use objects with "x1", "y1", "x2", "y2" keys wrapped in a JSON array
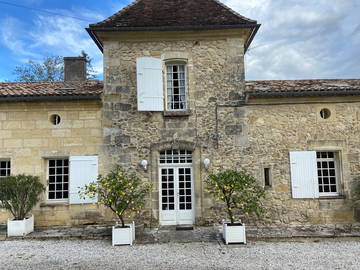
[{"x1": 0, "y1": 0, "x2": 360, "y2": 230}]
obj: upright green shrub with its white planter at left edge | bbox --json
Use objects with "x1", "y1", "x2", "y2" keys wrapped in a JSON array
[{"x1": 0, "y1": 174, "x2": 45, "y2": 236}]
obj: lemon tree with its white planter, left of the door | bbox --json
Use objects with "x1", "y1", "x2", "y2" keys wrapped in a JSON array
[{"x1": 79, "y1": 165, "x2": 151, "y2": 246}]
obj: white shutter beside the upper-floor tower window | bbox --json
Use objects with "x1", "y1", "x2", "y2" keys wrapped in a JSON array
[{"x1": 136, "y1": 57, "x2": 164, "y2": 112}]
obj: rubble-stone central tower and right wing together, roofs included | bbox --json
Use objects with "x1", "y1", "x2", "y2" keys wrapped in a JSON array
[{"x1": 88, "y1": 0, "x2": 359, "y2": 226}]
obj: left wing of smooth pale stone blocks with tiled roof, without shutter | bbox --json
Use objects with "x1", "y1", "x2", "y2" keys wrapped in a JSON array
[{"x1": 0, "y1": 82, "x2": 105, "y2": 226}]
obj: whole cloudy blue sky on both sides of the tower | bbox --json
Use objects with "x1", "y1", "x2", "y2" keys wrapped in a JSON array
[{"x1": 0, "y1": 0, "x2": 360, "y2": 81}]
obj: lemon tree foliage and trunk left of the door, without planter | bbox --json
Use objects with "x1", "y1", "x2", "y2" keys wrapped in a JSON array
[{"x1": 79, "y1": 166, "x2": 151, "y2": 227}]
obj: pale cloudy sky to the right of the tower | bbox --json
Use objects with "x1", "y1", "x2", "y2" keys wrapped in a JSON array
[{"x1": 222, "y1": 0, "x2": 360, "y2": 79}]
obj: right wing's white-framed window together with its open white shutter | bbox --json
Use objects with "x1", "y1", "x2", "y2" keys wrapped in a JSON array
[{"x1": 290, "y1": 151, "x2": 340, "y2": 198}]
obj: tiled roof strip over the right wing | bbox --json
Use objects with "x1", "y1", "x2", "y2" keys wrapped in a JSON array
[{"x1": 245, "y1": 79, "x2": 360, "y2": 97}]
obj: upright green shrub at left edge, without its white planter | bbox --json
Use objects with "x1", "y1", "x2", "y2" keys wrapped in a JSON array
[{"x1": 0, "y1": 174, "x2": 45, "y2": 220}]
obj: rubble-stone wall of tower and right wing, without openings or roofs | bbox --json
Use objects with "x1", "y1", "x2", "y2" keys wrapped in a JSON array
[{"x1": 103, "y1": 34, "x2": 359, "y2": 228}]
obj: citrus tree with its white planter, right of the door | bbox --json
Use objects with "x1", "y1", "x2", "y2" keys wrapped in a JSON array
[{"x1": 206, "y1": 169, "x2": 265, "y2": 244}]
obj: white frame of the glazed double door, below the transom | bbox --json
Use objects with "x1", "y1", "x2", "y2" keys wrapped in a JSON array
[{"x1": 158, "y1": 163, "x2": 195, "y2": 225}]
